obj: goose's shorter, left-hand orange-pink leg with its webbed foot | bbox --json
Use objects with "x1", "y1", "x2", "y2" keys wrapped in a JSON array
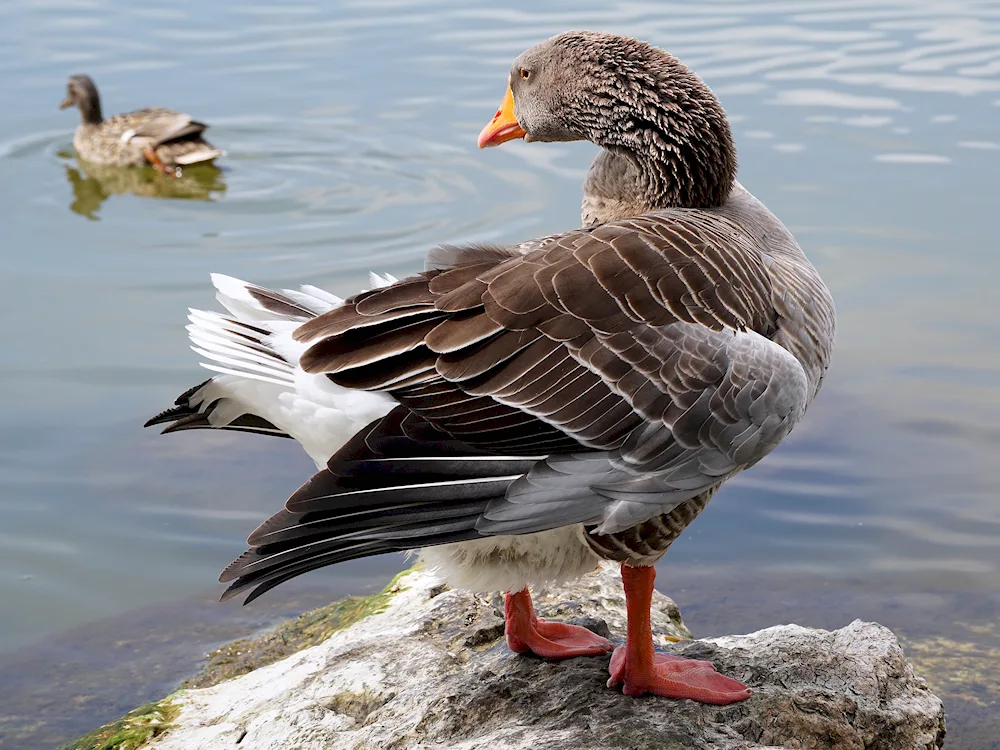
[{"x1": 503, "y1": 589, "x2": 614, "y2": 659}]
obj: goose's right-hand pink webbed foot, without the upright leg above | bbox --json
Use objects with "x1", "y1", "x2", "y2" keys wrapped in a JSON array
[{"x1": 608, "y1": 646, "x2": 751, "y2": 706}]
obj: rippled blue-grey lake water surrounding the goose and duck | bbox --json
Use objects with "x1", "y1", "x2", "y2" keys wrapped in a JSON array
[{"x1": 0, "y1": 0, "x2": 1000, "y2": 750}]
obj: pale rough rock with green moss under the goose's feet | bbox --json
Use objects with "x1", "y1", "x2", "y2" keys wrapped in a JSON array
[{"x1": 86, "y1": 566, "x2": 944, "y2": 750}]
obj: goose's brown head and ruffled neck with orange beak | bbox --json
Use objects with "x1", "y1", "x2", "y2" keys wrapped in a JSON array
[{"x1": 479, "y1": 31, "x2": 736, "y2": 211}]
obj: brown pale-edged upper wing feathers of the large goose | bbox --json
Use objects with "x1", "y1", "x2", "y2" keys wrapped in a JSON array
[{"x1": 295, "y1": 210, "x2": 776, "y2": 454}]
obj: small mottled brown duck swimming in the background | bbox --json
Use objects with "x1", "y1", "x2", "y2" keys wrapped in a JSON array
[{"x1": 59, "y1": 75, "x2": 222, "y2": 175}]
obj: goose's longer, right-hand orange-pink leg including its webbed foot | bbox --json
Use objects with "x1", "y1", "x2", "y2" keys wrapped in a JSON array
[{"x1": 608, "y1": 565, "x2": 750, "y2": 706}]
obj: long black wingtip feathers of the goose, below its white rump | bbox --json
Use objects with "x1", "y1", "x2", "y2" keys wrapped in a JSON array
[{"x1": 219, "y1": 407, "x2": 535, "y2": 604}]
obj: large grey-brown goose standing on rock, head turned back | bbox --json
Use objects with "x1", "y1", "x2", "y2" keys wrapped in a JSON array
[{"x1": 147, "y1": 31, "x2": 836, "y2": 705}]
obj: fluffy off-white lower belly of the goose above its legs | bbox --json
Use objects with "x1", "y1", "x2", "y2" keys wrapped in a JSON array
[{"x1": 420, "y1": 524, "x2": 601, "y2": 592}]
